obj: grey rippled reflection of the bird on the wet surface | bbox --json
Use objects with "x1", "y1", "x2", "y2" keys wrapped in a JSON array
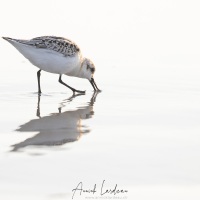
[{"x1": 12, "y1": 92, "x2": 98, "y2": 151}]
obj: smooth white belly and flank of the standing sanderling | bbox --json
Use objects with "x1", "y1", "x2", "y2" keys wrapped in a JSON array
[{"x1": 12, "y1": 42, "x2": 80, "y2": 74}]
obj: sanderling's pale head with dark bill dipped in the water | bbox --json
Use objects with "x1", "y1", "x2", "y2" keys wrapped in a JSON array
[{"x1": 81, "y1": 58, "x2": 101, "y2": 91}]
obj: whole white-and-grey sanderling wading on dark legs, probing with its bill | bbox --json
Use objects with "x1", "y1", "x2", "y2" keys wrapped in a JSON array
[{"x1": 3, "y1": 36, "x2": 100, "y2": 93}]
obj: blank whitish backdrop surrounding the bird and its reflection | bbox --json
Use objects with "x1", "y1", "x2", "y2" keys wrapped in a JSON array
[{"x1": 0, "y1": 0, "x2": 200, "y2": 200}]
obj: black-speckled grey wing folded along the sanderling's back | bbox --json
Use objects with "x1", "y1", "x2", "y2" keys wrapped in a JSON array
[{"x1": 18, "y1": 36, "x2": 80, "y2": 56}]
